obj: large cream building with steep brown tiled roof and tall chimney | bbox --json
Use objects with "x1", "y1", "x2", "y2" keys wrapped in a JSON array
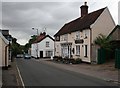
[{"x1": 54, "y1": 2, "x2": 115, "y2": 63}]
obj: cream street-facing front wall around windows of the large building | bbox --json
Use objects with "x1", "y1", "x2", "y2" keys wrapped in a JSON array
[{"x1": 55, "y1": 29, "x2": 90, "y2": 62}]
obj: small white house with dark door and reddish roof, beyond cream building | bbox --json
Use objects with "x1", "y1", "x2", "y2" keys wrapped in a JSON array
[{"x1": 31, "y1": 32, "x2": 54, "y2": 58}]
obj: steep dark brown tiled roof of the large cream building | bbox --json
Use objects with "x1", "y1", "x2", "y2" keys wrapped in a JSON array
[{"x1": 54, "y1": 7, "x2": 106, "y2": 36}]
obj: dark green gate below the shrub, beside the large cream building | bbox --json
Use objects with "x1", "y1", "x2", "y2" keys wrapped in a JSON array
[{"x1": 97, "y1": 48, "x2": 106, "y2": 64}]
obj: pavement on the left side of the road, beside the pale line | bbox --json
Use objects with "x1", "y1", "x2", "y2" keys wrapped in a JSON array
[{"x1": 2, "y1": 58, "x2": 22, "y2": 88}]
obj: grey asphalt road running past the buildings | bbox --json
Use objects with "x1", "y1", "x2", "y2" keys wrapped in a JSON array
[{"x1": 17, "y1": 59, "x2": 115, "y2": 86}]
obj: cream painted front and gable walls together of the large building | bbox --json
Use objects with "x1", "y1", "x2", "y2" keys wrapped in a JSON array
[{"x1": 55, "y1": 8, "x2": 115, "y2": 62}]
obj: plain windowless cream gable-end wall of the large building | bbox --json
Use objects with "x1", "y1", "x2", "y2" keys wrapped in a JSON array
[{"x1": 91, "y1": 8, "x2": 115, "y2": 43}]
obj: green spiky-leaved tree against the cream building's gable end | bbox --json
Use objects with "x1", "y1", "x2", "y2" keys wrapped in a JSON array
[{"x1": 94, "y1": 34, "x2": 112, "y2": 50}]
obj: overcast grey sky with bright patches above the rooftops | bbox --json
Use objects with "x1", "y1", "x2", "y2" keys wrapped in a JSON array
[{"x1": 0, "y1": 0, "x2": 120, "y2": 45}]
